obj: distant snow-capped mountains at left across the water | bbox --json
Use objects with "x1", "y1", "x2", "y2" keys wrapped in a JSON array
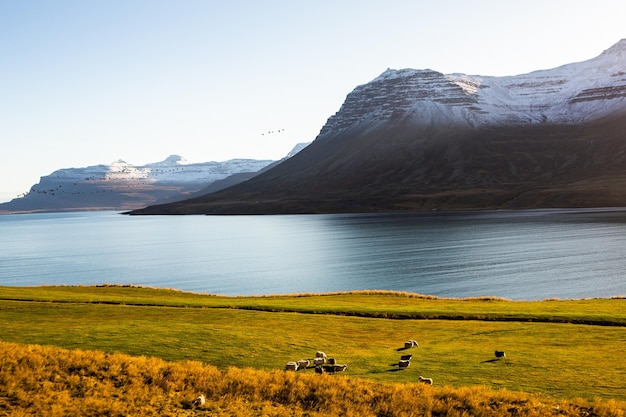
[{"x1": 0, "y1": 143, "x2": 307, "y2": 214}]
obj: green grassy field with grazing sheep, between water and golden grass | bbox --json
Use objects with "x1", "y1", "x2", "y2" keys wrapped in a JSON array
[{"x1": 0, "y1": 287, "x2": 626, "y2": 401}]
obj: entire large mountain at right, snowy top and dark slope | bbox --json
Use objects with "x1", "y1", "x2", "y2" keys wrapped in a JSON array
[{"x1": 131, "y1": 39, "x2": 626, "y2": 214}]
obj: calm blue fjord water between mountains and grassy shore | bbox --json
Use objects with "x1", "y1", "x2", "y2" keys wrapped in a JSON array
[{"x1": 0, "y1": 209, "x2": 626, "y2": 300}]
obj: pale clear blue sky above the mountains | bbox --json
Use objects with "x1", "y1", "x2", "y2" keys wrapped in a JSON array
[{"x1": 0, "y1": 0, "x2": 626, "y2": 202}]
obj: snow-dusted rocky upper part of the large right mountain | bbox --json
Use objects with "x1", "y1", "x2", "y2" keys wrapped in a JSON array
[{"x1": 320, "y1": 39, "x2": 626, "y2": 135}]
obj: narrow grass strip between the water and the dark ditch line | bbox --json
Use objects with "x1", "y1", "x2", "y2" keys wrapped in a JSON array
[{"x1": 0, "y1": 286, "x2": 626, "y2": 326}]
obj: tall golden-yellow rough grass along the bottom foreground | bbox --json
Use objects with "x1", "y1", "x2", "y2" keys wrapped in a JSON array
[{"x1": 0, "y1": 342, "x2": 626, "y2": 417}]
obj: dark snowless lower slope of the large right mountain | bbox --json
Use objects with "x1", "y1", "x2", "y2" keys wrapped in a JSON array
[{"x1": 127, "y1": 111, "x2": 626, "y2": 214}]
